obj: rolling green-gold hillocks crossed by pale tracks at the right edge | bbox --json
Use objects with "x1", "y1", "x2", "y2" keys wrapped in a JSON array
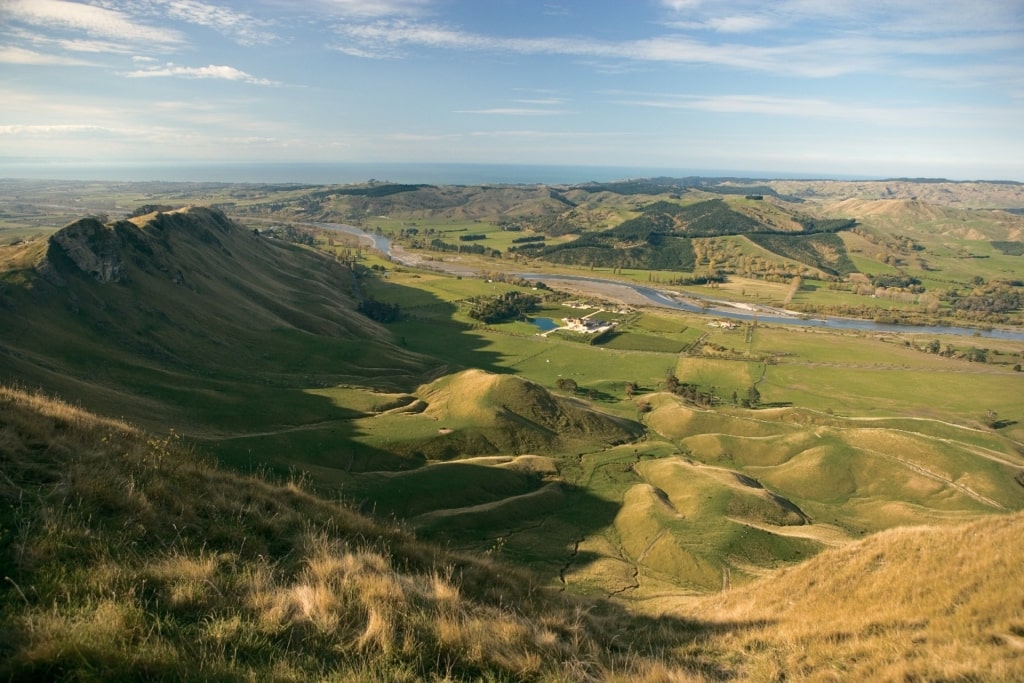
[{"x1": 647, "y1": 398, "x2": 1024, "y2": 535}]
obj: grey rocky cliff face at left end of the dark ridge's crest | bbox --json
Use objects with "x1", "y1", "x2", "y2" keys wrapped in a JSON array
[{"x1": 37, "y1": 218, "x2": 125, "y2": 284}]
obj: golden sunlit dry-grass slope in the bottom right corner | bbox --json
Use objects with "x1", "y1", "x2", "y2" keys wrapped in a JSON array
[{"x1": 679, "y1": 513, "x2": 1024, "y2": 681}]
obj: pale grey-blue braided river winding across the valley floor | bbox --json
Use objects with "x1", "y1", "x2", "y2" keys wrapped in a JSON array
[{"x1": 312, "y1": 223, "x2": 1024, "y2": 341}]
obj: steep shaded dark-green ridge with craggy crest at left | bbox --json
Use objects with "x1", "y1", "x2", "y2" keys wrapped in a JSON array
[{"x1": 0, "y1": 208, "x2": 429, "y2": 431}]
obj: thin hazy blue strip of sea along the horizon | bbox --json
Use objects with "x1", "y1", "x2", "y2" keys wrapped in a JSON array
[{"x1": 0, "y1": 161, "x2": 878, "y2": 185}]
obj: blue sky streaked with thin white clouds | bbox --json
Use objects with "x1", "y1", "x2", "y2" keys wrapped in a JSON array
[{"x1": 0, "y1": 0, "x2": 1024, "y2": 181}]
